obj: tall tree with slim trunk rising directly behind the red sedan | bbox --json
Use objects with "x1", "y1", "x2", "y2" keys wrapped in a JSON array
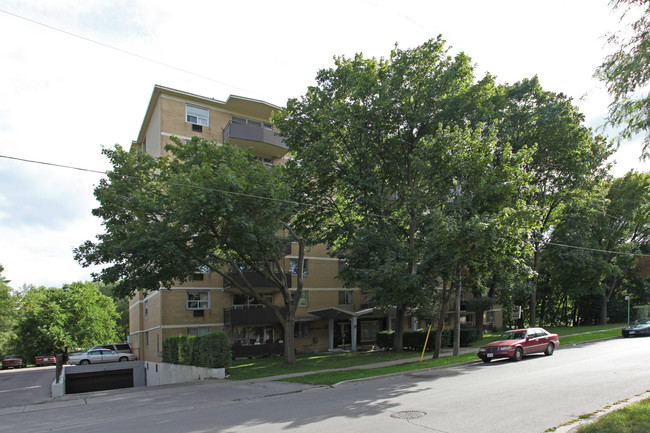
[{"x1": 486, "y1": 77, "x2": 612, "y2": 326}]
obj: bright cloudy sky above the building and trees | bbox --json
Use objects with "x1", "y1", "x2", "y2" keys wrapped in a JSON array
[{"x1": 0, "y1": 0, "x2": 650, "y2": 289}]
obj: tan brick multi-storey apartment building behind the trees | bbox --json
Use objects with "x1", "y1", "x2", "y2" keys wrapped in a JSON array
[{"x1": 129, "y1": 86, "x2": 500, "y2": 361}]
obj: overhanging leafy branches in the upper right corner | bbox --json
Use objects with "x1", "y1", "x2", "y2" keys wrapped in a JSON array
[{"x1": 596, "y1": 0, "x2": 650, "y2": 159}]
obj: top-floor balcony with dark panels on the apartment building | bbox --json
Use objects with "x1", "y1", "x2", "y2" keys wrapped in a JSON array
[{"x1": 223, "y1": 121, "x2": 287, "y2": 158}]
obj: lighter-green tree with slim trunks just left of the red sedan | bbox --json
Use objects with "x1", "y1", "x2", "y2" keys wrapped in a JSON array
[{"x1": 420, "y1": 125, "x2": 532, "y2": 357}]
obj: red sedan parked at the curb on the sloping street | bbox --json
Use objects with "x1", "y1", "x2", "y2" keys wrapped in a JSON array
[{"x1": 478, "y1": 328, "x2": 560, "y2": 362}]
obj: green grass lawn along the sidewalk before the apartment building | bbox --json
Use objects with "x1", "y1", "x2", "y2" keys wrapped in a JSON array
[{"x1": 228, "y1": 324, "x2": 623, "y2": 385}]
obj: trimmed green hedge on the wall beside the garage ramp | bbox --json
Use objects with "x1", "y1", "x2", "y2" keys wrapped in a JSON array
[{"x1": 162, "y1": 331, "x2": 232, "y2": 368}]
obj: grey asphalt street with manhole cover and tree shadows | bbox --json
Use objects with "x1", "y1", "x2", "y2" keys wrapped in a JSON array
[{"x1": 0, "y1": 338, "x2": 650, "y2": 433}]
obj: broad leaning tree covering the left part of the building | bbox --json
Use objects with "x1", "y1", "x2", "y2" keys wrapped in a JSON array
[{"x1": 75, "y1": 137, "x2": 307, "y2": 364}]
